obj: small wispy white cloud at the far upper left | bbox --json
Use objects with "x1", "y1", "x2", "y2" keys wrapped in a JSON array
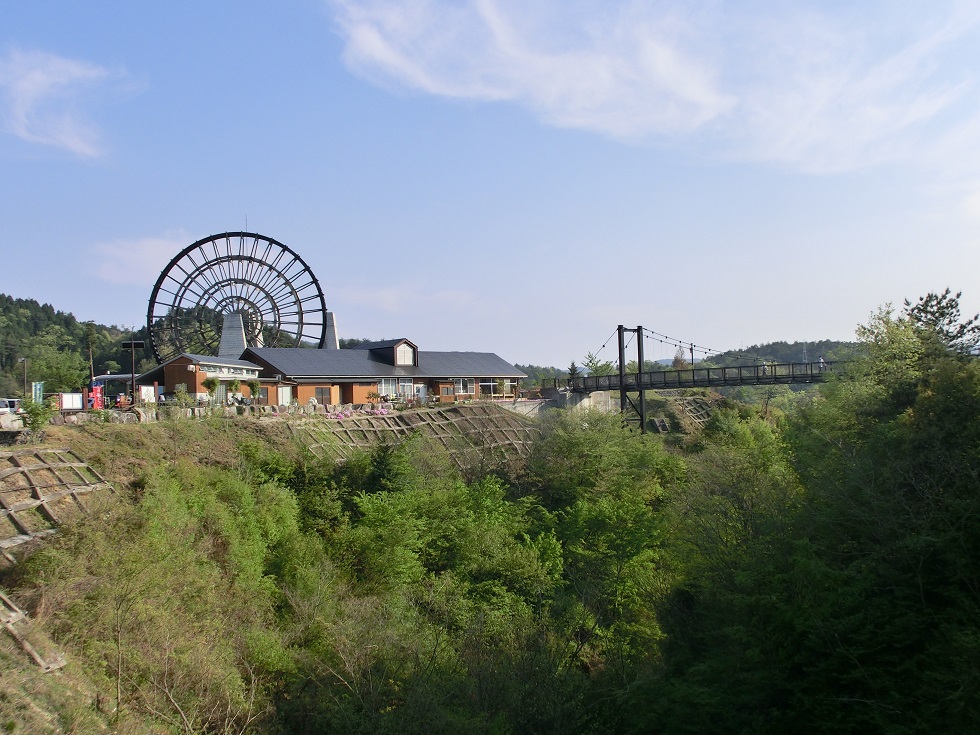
[{"x1": 0, "y1": 50, "x2": 113, "y2": 158}]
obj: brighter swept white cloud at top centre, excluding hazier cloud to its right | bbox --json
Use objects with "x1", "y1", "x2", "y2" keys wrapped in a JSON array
[{"x1": 333, "y1": 0, "x2": 735, "y2": 137}]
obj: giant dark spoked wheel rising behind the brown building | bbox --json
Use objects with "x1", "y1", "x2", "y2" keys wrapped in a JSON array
[{"x1": 146, "y1": 232, "x2": 327, "y2": 363}]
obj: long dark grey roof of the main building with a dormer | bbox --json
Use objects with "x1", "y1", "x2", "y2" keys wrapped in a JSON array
[{"x1": 242, "y1": 348, "x2": 527, "y2": 379}]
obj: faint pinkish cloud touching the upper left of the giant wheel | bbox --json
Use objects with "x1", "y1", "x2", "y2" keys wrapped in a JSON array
[{"x1": 89, "y1": 230, "x2": 195, "y2": 286}]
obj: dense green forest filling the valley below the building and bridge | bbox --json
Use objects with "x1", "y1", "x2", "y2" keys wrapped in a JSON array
[{"x1": 0, "y1": 291, "x2": 980, "y2": 735}]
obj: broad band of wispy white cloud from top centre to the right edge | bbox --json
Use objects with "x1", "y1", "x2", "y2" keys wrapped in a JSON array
[{"x1": 326, "y1": 0, "x2": 980, "y2": 172}]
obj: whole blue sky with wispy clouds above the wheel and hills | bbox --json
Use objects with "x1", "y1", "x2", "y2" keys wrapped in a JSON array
[{"x1": 0, "y1": 0, "x2": 980, "y2": 367}]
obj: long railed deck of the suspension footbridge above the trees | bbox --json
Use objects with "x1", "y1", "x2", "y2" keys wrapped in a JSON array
[{"x1": 568, "y1": 362, "x2": 832, "y2": 393}]
